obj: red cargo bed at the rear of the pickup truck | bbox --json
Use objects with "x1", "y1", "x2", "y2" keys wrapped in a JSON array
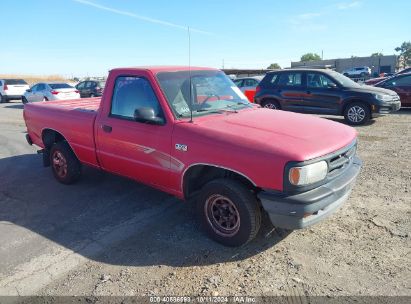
[{"x1": 24, "y1": 97, "x2": 101, "y2": 166}]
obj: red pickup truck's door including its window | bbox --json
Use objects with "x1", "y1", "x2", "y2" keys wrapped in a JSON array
[{"x1": 95, "y1": 75, "x2": 172, "y2": 189}]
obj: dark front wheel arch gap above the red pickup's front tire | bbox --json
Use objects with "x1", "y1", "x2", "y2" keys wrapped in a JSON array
[{"x1": 181, "y1": 163, "x2": 258, "y2": 200}]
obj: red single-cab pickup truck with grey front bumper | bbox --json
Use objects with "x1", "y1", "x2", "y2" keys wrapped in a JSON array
[{"x1": 24, "y1": 67, "x2": 361, "y2": 246}]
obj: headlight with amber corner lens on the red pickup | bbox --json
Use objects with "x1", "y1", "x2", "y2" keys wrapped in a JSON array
[{"x1": 288, "y1": 161, "x2": 328, "y2": 186}]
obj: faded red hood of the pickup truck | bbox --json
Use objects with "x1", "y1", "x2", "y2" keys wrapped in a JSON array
[{"x1": 186, "y1": 108, "x2": 357, "y2": 161}]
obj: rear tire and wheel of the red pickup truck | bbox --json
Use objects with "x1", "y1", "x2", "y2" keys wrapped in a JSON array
[{"x1": 50, "y1": 141, "x2": 81, "y2": 185}]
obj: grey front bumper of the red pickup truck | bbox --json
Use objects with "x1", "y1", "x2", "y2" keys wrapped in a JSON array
[{"x1": 258, "y1": 156, "x2": 362, "y2": 229}]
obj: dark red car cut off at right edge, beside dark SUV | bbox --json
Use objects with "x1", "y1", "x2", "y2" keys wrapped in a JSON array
[{"x1": 375, "y1": 73, "x2": 411, "y2": 107}]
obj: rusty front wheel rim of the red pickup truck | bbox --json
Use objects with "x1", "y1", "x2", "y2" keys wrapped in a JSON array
[{"x1": 204, "y1": 194, "x2": 240, "y2": 237}]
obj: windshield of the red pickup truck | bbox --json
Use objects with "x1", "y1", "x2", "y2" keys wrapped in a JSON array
[{"x1": 157, "y1": 71, "x2": 252, "y2": 117}]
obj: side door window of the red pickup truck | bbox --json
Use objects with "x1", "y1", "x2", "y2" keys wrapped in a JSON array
[{"x1": 110, "y1": 76, "x2": 163, "y2": 120}]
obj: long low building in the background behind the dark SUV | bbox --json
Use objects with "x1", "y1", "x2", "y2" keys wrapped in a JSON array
[{"x1": 291, "y1": 55, "x2": 397, "y2": 75}]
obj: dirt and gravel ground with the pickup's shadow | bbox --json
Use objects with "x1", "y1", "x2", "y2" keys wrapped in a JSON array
[{"x1": 0, "y1": 103, "x2": 411, "y2": 296}]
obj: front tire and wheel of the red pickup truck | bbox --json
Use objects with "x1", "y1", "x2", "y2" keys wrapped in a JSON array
[{"x1": 196, "y1": 178, "x2": 261, "y2": 247}]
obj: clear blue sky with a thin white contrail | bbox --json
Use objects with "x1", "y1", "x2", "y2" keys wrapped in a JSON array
[{"x1": 0, "y1": 0, "x2": 411, "y2": 77}]
